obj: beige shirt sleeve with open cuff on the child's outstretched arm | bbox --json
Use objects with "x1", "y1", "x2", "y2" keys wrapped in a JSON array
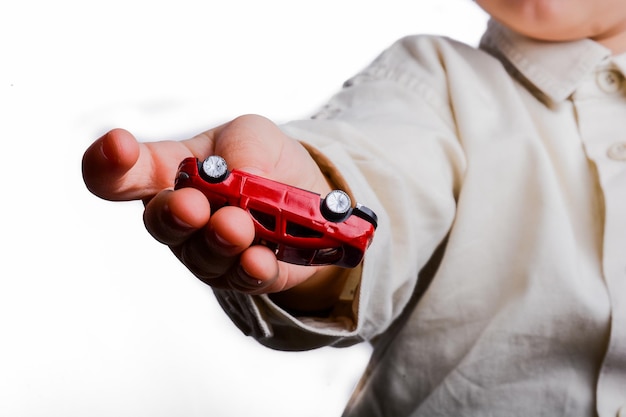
[{"x1": 215, "y1": 37, "x2": 465, "y2": 350}]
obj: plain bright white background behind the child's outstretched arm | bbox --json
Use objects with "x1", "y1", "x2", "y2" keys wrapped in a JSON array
[{"x1": 0, "y1": 0, "x2": 486, "y2": 417}]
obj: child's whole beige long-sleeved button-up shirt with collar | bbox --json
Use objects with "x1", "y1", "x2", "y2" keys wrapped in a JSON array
[{"x1": 216, "y1": 23, "x2": 626, "y2": 417}]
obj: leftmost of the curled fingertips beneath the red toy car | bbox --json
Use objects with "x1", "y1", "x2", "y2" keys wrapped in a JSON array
[{"x1": 144, "y1": 188, "x2": 211, "y2": 246}]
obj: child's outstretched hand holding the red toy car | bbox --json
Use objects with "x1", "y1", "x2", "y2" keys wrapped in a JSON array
[{"x1": 83, "y1": 116, "x2": 340, "y2": 309}]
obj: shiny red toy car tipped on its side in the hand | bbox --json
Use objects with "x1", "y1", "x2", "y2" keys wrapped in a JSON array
[{"x1": 175, "y1": 155, "x2": 377, "y2": 268}]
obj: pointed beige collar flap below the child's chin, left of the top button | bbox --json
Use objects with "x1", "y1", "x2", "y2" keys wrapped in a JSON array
[{"x1": 480, "y1": 19, "x2": 612, "y2": 102}]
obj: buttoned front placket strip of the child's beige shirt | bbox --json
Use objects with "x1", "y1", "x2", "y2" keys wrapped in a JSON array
[{"x1": 573, "y1": 65, "x2": 626, "y2": 417}]
